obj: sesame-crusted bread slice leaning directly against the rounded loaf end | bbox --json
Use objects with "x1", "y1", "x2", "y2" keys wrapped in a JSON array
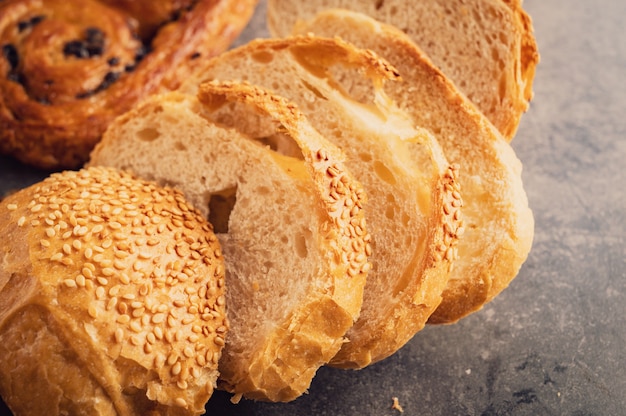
[{"x1": 90, "y1": 84, "x2": 370, "y2": 401}]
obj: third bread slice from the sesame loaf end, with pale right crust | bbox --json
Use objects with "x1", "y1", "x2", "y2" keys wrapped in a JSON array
[{"x1": 292, "y1": 10, "x2": 534, "y2": 323}]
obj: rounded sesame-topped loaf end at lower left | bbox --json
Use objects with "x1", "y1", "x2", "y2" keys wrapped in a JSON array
[{"x1": 0, "y1": 168, "x2": 228, "y2": 416}]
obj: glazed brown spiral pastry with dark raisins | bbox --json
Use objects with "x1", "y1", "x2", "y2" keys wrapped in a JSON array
[{"x1": 0, "y1": 0, "x2": 257, "y2": 170}]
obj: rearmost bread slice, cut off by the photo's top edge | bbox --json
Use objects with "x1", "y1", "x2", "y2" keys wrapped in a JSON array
[{"x1": 267, "y1": 0, "x2": 539, "y2": 141}]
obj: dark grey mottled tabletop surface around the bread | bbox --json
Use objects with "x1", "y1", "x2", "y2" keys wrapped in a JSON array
[{"x1": 0, "y1": 0, "x2": 626, "y2": 416}]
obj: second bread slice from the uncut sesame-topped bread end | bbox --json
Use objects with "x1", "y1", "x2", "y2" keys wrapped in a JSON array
[{"x1": 178, "y1": 36, "x2": 461, "y2": 368}]
